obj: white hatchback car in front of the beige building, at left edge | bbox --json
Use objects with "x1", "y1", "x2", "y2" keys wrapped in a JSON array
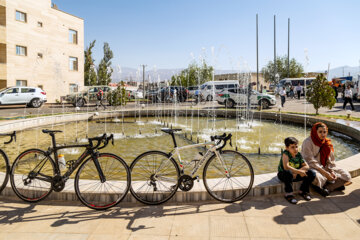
[{"x1": 0, "y1": 87, "x2": 47, "y2": 108}]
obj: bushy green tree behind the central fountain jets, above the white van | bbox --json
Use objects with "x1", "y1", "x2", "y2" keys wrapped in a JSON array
[{"x1": 170, "y1": 62, "x2": 214, "y2": 87}]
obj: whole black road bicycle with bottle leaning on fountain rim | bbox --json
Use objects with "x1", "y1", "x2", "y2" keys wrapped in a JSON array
[{"x1": 10, "y1": 130, "x2": 131, "y2": 210}]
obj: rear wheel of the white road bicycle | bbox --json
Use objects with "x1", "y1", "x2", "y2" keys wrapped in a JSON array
[{"x1": 130, "y1": 151, "x2": 180, "y2": 205}]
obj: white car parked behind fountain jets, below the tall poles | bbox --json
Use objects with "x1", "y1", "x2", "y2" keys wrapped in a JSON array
[{"x1": 216, "y1": 88, "x2": 276, "y2": 109}]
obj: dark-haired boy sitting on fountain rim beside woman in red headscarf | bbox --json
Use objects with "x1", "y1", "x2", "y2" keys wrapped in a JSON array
[{"x1": 278, "y1": 137, "x2": 316, "y2": 204}]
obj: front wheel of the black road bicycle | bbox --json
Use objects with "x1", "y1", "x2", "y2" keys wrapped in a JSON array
[{"x1": 74, "y1": 153, "x2": 131, "y2": 210}]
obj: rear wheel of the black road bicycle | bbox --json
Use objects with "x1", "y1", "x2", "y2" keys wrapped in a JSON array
[{"x1": 10, "y1": 149, "x2": 55, "y2": 202}]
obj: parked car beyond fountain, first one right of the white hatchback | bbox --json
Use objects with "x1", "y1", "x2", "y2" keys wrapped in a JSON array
[{"x1": 65, "y1": 86, "x2": 111, "y2": 107}]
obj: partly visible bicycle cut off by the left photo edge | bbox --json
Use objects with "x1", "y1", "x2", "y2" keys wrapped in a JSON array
[{"x1": 0, "y1": 131, "x2": 16, "y2": 193}]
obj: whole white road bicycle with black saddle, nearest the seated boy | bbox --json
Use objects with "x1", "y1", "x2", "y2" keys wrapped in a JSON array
[{"x1": 130, "y1": 128, "x2": 254, "y2": 205}]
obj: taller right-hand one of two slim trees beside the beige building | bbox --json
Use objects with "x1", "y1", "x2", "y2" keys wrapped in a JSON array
[{"x1": 97, "y1": 42, "x2": 114, "y2": 85}]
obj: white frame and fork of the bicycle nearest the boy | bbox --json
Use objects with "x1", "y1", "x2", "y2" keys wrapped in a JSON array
[{"x1": 159, "y1": 142, "x2": 229, "y2": 177}]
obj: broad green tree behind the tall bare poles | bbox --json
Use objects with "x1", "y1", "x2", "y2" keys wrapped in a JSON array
[{"x1": 261, "y1": 55, "x2": 304, "y2": 84}]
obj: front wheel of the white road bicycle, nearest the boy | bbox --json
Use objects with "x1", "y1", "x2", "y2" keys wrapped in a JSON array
[{"x1": 203, "y1": 150, "x2": 254, "y2": 203}]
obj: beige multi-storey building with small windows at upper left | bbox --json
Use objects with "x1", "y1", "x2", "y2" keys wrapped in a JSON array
[{"x1": 0, "y1": 0, "x2": 84, "y2": 102}]
